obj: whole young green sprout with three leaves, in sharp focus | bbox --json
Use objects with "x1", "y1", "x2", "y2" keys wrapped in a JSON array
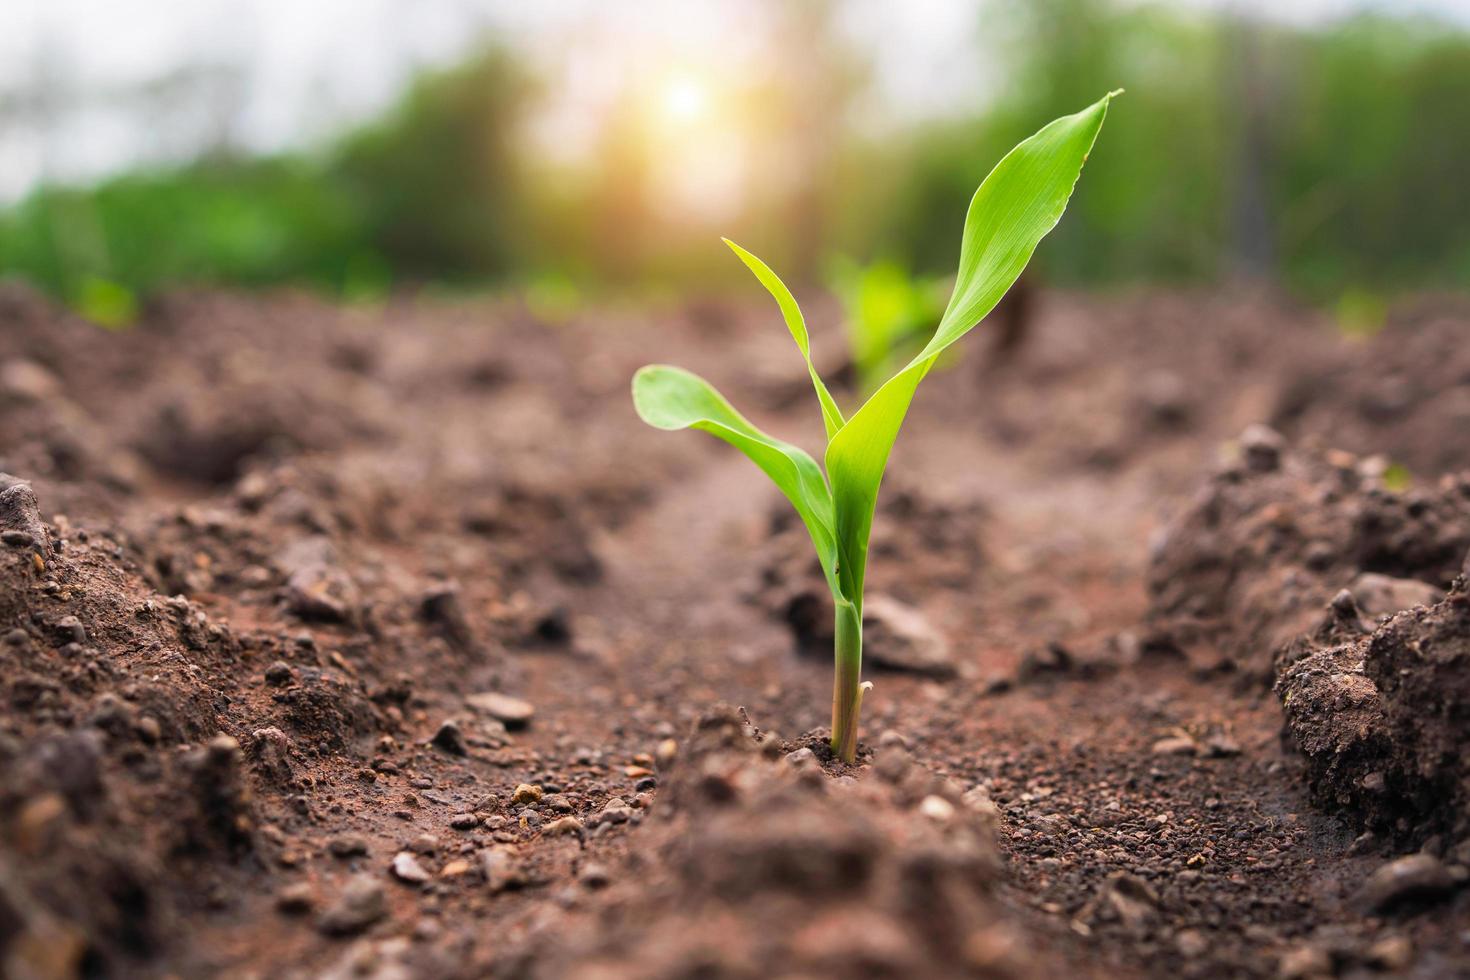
[{"x1": 634, "y1": 93, "x2": 1119, "y2": 763}]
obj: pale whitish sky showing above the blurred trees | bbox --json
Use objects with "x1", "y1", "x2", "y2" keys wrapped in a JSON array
[{"x1": 0, "y1": 0, "x2": 1470, "y2": 200}]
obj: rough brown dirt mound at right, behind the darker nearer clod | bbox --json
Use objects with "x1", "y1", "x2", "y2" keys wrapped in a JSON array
[{"x1": 1148, "y1": 437, "x2": 1470, "y2": 683}]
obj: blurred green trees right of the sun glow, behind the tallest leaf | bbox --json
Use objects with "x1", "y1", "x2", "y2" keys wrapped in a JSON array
[{"x1": 845, "y1": 0, "x2": 1470, "y2": 301}]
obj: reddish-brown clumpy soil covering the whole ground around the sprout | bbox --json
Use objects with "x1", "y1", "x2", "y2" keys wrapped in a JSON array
[{"x1": 0, "y1": 279, "x2": 1470, "y2": 980}]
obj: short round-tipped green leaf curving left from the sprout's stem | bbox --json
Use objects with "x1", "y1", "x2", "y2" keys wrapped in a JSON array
[{"x1": 634, "y1": 364, "x2": 838, "y2": 595}]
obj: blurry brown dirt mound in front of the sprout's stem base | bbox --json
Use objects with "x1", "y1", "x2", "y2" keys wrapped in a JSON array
[{"x1": 534, "y1": 710, "x2": 1064, "y2": 979}]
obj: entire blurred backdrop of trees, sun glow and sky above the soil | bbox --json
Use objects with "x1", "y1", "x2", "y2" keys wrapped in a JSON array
[{"x1": 0, "y1": 0, "x2": 1470, "y2": 326}]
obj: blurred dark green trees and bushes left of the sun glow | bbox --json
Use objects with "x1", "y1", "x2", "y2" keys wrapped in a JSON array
[{"x1": 0, "y1": 50, "x2": 528, "y2": 307}]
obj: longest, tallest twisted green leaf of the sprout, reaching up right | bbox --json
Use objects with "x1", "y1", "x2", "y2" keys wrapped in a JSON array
[{"x1": 826, "y1": 93, "x2": 1117, "y2": 611}]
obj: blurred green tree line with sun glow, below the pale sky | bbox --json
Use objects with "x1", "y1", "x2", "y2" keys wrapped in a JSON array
[{"x1": 0, "y1": 0, "x2": 1470, "y2": 323}]
